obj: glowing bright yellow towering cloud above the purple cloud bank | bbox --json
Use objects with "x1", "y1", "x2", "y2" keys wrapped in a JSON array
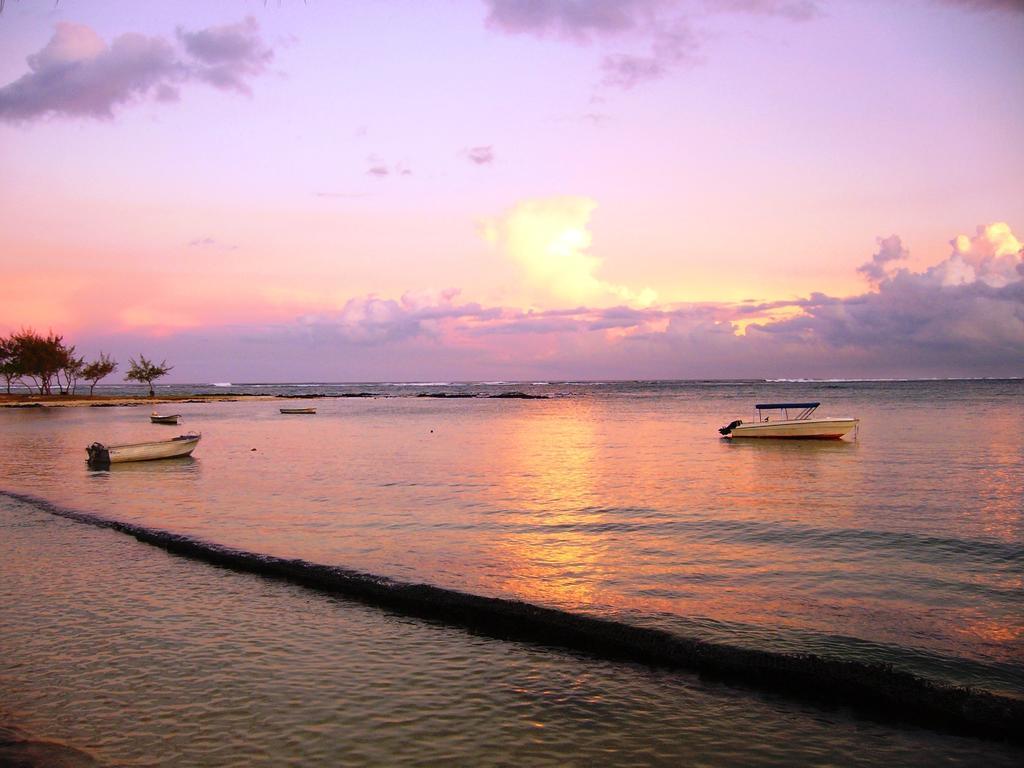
[{"x1": 482, "y1": 197, "x2": 655, "y2": 305}]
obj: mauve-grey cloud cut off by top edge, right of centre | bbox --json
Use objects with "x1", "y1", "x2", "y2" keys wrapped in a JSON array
[{"x1": 484, "y1": 0, "x2": 820, "y2": 88}]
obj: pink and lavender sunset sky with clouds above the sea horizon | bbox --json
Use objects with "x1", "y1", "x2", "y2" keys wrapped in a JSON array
[{"x1": 0, "y1": 0, "x2": 1024, "y2": 382}]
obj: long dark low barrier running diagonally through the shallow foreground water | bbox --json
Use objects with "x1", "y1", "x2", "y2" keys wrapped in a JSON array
[{"x1": 0, "y1": 489, "x2": 1024, "y2": 743}]
